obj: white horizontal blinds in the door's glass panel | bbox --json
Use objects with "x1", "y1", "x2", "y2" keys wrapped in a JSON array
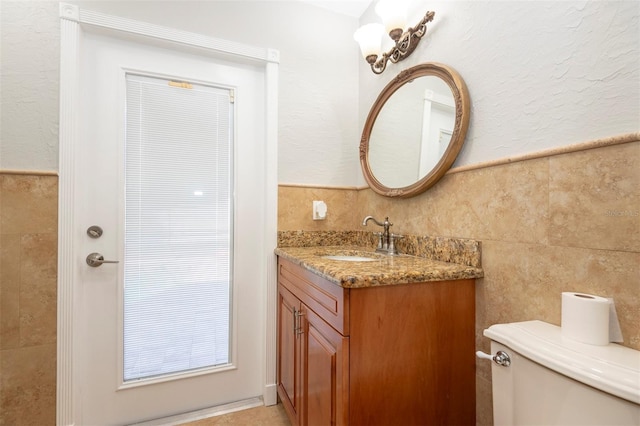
[{"x1": 123, "y1": 74, "x2": 233, "y2": 381}]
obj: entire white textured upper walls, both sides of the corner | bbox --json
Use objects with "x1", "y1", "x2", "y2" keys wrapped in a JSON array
[{"x1": 0, "y1": 0, "x2": 640, "y2": 186}]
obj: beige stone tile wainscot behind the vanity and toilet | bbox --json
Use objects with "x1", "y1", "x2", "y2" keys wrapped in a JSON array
[{"x1": 278, "y1": 138, "x2": 640, "y2": 425}]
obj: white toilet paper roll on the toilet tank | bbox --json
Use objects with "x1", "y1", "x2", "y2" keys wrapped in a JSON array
[{"x1": 561, "y1": 292, "x2": 622, "y2": 345}]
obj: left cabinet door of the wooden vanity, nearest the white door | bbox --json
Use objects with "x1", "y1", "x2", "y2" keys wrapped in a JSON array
[{"x1": 277, "y1": 285, "x2": 302, "y2": 425}]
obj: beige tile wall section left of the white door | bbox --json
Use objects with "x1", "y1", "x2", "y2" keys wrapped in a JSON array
[{"x1": 0, "y1": 173, "x2": 58, "y2": 426}]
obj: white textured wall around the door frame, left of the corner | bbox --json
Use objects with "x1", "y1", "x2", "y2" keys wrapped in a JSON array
[{"x1": 0, "y1": 0, "x2": 360, "y2": 185}]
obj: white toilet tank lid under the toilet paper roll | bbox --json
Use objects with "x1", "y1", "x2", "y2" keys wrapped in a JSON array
[{"x1": 484, "y1": 321, "x2": 640, "y2": 404}]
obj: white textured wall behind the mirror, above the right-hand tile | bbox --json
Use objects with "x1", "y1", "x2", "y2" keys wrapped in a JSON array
[{"x1": 359, "y1": 0, "x2": 640, "y2": 183}]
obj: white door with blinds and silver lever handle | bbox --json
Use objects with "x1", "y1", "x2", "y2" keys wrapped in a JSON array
[{"x1": 76, "y1": 29, "x2": 264, "y2": 424}]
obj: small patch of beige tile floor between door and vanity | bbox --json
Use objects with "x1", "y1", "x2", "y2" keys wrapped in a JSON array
[{"x1": 181, "y1": 404, "x2": 291, "y2": 426}]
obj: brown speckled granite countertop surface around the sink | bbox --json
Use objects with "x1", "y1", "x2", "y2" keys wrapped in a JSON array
[{"x1": 275, "y1": 245, "x2": 483, "y2": 288}]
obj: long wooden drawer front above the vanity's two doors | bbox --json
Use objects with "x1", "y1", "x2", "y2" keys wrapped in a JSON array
[{"x1": 278, "y1": 258, "x2": 349, "y2": 336}]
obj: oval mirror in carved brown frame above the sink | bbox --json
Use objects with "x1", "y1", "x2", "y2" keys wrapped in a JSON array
[{"x1": 360, "y1": 62, "x2": 470, "y2": 198}]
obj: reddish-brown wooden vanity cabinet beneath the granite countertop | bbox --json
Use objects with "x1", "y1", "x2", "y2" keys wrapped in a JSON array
[{"x1": 277, "y1": 258, "x2": 475, "y2": 426}]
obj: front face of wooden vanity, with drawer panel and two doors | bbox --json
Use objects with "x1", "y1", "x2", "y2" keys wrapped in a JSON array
[{"x1": 277, "y1": 260, "x2": 349, "y2": 425}]
